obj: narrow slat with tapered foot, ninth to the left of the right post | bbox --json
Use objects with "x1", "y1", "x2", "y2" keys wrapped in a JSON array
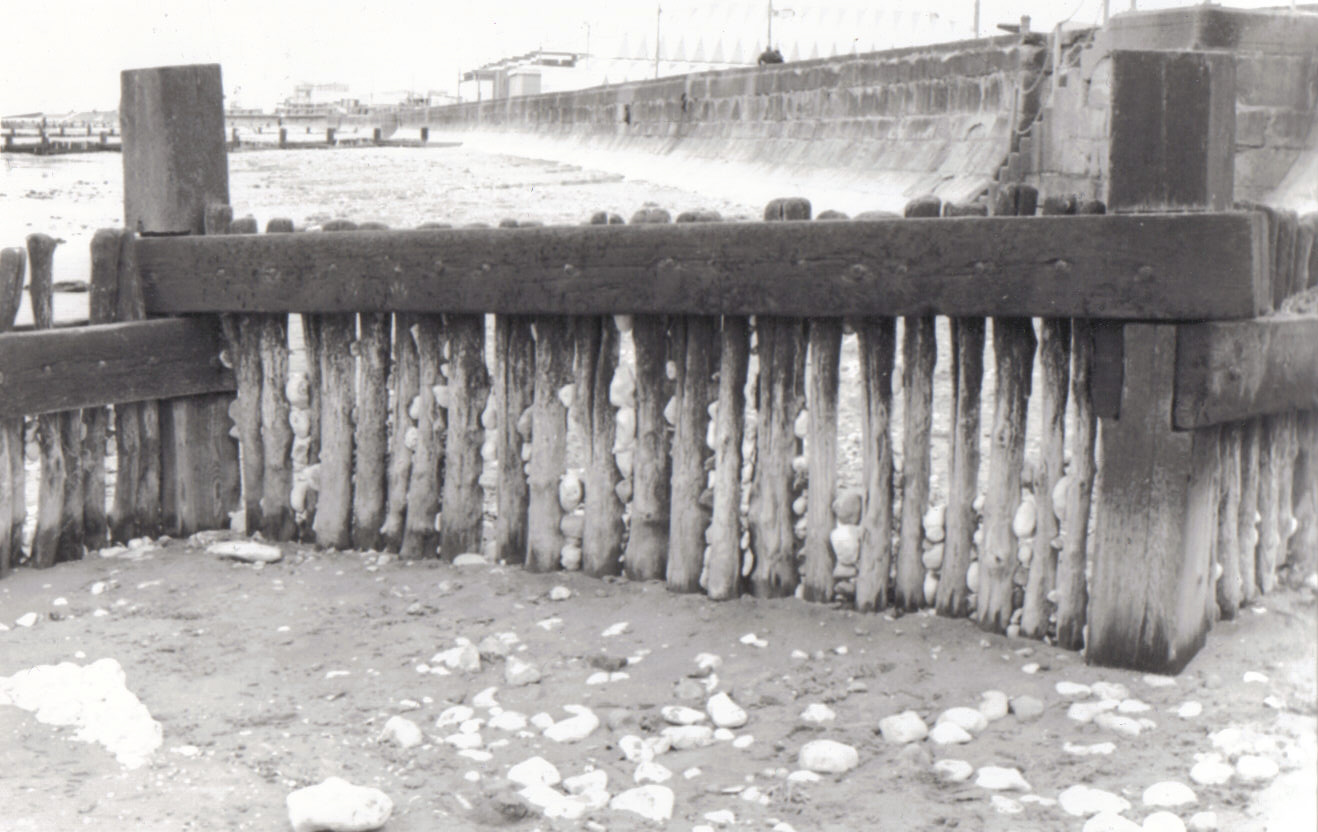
[{"x1": 705, "y1": 315, "x2": 750, "y2": 600}]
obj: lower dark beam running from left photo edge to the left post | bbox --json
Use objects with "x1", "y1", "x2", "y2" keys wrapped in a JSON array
[{"x1": 0, "y1": 316, "x2": 235, "y2": 418}]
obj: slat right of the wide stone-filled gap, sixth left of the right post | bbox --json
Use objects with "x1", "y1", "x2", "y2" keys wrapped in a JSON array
[{"x1": 855, "y1": 318, "x2": 896, "y2": 612}]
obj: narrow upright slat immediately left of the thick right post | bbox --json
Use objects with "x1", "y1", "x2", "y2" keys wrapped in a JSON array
[{"x1": 1057, "y1": 200, "x2": 1106, "y2": 650}]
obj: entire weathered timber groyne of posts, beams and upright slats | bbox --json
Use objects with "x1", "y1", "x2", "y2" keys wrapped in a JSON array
[{"x1": 0, "y1": 55, "x2": 1318, "y2": 671}]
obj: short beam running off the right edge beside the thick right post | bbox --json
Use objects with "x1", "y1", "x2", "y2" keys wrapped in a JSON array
[{"x1": 1172, "y1": 315, "x2": 1318, "y2": 429}]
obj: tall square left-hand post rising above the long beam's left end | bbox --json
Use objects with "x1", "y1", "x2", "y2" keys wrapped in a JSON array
[{"x1": 119, "y1": 63, "x2": 239, "y2": 534}]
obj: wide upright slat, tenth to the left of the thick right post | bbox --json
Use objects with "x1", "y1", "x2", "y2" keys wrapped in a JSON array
[{"x1": 667, "y1": 211, "x2": 721, "y2": 592}]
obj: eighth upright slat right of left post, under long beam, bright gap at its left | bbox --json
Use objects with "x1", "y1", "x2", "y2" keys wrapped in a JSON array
[{"x1": 494, "y1": 315, "x2": 535, "y2": 563}]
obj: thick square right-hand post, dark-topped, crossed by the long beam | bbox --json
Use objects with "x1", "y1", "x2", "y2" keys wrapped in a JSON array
[{"x1": 1073, "y1": 51, "x2": 1251, "y2": 672}]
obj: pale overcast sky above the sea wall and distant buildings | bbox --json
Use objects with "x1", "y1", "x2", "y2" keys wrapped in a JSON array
[{"x1": 0, "y1": 0, "x2": 1285, "y2": 115}]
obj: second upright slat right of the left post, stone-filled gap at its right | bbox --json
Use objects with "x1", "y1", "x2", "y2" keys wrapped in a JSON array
[{"x1": 258, "y1": 219, "x2": 297, "y2": 541}]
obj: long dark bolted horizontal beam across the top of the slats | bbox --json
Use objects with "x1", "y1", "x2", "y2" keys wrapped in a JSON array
[{"x1": 137, "y1": 214, "x2": 1267, "y2": 320}]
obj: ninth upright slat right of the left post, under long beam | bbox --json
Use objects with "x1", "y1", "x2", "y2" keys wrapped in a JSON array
[{"x1": 526, "y1": 315, "x2": 572, "y2": 572}]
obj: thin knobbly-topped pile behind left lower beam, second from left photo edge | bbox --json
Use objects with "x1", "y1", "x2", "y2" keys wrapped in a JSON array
[{"x1": 28, "y1": 233, "x2": 82, "y2": 568}]
